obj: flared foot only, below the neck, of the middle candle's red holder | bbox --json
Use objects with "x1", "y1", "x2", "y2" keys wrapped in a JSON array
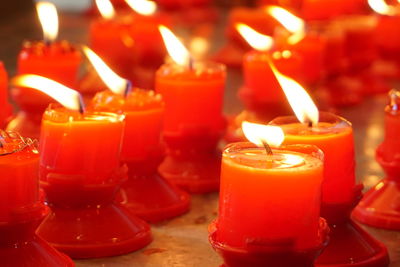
[{"x1": 158, "y1": 150, "x2": 221, "y2": 194}]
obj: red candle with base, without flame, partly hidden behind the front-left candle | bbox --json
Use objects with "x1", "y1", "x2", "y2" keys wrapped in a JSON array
[{"x1": 92, "y1": 88, "x2": 190, "y2": 223}]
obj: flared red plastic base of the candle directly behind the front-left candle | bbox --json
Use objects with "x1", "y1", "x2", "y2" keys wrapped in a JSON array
[{"x1": 117, "y1": 163, "x2": 190, "y2": 223}]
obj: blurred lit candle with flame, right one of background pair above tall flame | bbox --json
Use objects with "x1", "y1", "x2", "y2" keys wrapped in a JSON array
[{"x1": 265, "y1": 6, "x2": 325, "y2": 83}]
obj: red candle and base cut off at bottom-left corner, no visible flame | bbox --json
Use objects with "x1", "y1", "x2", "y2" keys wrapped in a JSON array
[{"x1": 0, "y1": 131, "x2": 75, "y2": 267}]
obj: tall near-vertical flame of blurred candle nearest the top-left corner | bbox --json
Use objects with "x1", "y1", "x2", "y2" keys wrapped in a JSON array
[{"x1": 36, "y1": 2, "x2": 58, "y2": 42}]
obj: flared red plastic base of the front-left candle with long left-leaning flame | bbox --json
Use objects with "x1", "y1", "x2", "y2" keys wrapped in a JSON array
[{"x1": 37, "y1": 181, "x2": 152, "y2": 258}]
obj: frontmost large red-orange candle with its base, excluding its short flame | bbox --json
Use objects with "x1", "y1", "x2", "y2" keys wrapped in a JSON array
[{"x1": 209, "y1": 142, "x2": 329, "y2": 267}]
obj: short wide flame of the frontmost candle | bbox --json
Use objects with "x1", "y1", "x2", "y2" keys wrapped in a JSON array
[{"x1": 242, "y1": 121, "x2": 285, "y2": 147}]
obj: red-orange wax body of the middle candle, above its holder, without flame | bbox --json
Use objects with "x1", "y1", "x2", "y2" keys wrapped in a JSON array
[{"x1": 156, "y1": 62, "x2": 226, "y2": 135}]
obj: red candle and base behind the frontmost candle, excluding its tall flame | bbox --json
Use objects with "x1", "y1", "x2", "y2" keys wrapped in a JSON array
[{"x1": 270, "y1": 112, "x2": 388, "y2": 267}]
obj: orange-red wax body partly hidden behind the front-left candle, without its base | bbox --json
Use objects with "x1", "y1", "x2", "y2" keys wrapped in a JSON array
[{"x1": 92, "y1": 88, "x2": 164, "y2": 162}]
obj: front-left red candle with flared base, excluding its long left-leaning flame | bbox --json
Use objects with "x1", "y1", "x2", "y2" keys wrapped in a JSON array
[{"x1": 37, "y1": 105, "x2": 152, "y2": 258}]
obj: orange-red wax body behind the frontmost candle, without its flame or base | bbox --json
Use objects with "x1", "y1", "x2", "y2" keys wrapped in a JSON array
[{"x1": 271, "y1": 112, "x2": 355, "y2": 205}]
